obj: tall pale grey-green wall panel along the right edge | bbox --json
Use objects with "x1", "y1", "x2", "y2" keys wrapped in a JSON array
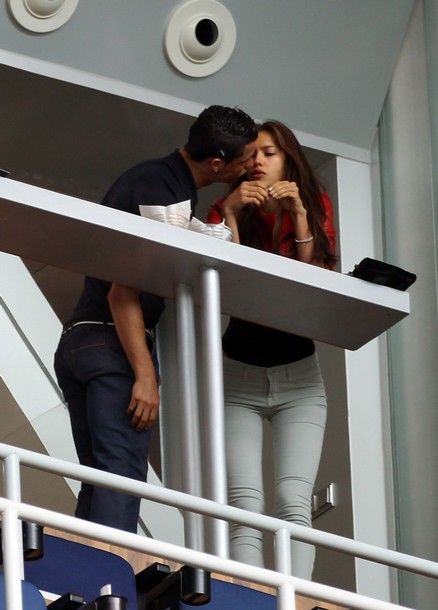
[{"x1": 381, "y1": 2, "x2": 438, "y2": 610}]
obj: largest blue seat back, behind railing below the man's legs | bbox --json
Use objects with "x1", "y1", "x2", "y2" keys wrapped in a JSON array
[{"x1": 24, "y1": 534, "x2": 137, "y2": 610}]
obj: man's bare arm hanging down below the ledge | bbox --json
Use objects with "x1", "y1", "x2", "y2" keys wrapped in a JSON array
[{"x1": 108, "y1": 284, "x2": 160, "y2": 430}]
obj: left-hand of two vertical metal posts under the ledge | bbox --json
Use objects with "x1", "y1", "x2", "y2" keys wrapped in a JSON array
[{"x1": 175, "y1": 284, "x2": 204, "y2": 551}]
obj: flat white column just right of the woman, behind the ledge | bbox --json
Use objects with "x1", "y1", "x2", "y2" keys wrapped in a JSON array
[{"x1": 337, "y1": 158, "x2": 393, "y2": 601}]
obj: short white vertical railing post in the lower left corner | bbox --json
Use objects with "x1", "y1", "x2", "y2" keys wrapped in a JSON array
[{"x1": 2, "y1": 504, "x2": 23, "y2": 610}]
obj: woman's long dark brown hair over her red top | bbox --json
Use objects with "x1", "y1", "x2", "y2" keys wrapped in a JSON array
[{"x1": 239, "y1": 120, "x2": 336, "y2": 268}]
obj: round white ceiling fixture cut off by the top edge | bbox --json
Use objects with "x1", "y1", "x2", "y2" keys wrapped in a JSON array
[{"x1": 8, "y1": 0, "x2": 79, "y2": 32}]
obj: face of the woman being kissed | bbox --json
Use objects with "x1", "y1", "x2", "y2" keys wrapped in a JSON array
[{"x1": 248, "y1": 131, "x2": 286, "y2": 185}]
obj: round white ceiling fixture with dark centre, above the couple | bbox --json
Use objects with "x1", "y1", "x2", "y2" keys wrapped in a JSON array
[{"x1": 164, "y1": 0, "x2": 236, "y2": 77}]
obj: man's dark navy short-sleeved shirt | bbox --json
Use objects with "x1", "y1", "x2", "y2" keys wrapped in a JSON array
[{"x1": 66, "y1": 152, "x2": 198, "y2": 328}]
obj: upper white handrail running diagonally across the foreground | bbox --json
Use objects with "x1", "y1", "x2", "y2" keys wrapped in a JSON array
[{"x1": 0, "y1": 443, "x2": 438, "y2": 579}]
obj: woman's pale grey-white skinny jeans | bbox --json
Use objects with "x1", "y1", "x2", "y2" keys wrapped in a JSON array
[{"x1": 224, "y1": 354, "x2": 327, "y2": 580}]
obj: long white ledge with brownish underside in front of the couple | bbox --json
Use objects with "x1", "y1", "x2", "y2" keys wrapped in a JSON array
[{"x1": 0, "y1": 179, "x2": 409, "y2": 350}]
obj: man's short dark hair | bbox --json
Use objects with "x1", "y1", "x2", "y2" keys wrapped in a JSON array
[{"x1": 184, "y1": 106, "x2": 257, "y2": 163}]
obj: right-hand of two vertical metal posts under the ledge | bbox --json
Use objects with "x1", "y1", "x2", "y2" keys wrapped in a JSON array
[{"x1": 201, "y1": 267, "x2": 229, "y2": 558}]
